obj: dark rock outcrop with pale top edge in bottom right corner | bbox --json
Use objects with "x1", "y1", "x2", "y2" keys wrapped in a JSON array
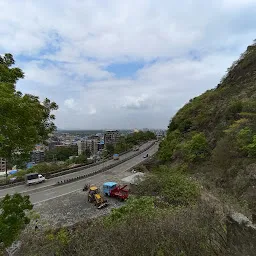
[{"x1": 227, "y1": 213, "x2": 256, "y2": 256}]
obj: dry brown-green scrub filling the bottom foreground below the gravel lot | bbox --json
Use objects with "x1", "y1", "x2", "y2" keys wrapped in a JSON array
[{"x1": 19, "y1": 203, "x2": 226, "y2": 256}]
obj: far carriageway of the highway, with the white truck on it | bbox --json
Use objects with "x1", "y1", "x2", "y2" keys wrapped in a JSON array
[{"x1": 0, "y1": 141, "x2": 152, "y2": 198}]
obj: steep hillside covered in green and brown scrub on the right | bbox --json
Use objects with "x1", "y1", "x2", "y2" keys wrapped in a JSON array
[{"x1": 159, "y1": 43, "x2": 256, "y2": 211}]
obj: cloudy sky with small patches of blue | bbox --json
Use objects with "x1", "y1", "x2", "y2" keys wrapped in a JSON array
[{"x1": 0, "y1": 0, "x2": 256, "y2": 129}]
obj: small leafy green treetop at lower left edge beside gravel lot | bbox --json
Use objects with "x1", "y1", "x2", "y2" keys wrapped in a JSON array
[{"x1": 0, "y1": 193, "x2": 33, "y2": 249}]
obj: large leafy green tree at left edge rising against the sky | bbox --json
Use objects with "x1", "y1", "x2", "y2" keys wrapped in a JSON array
[{"x1": 0, "y1": 54, "x2": 58, "y2": 177}]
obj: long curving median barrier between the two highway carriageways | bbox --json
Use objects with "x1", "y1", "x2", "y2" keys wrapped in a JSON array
[{"x1": 55, "y1": 142, "x2": 155, "y2": 186}]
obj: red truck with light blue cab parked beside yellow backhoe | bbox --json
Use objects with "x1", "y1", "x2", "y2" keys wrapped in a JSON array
[{"x1": 103, "y1": 182, "x2": 129, "y2": 201}]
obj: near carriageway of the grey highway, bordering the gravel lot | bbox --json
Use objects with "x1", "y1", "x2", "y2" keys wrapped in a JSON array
[{"x1": 30, "y1": 144, "x2": 158, "y2": 204}]
